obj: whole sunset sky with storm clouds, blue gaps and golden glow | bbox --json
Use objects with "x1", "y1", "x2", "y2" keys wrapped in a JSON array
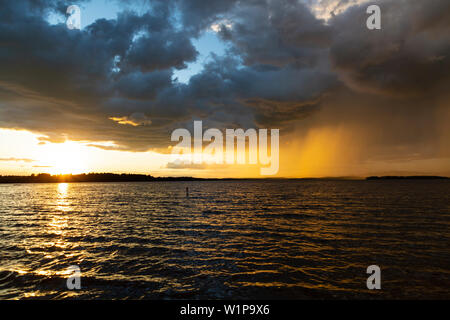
[{"x1": 0, "y1": 0, "x2": 450, "y2": 178}]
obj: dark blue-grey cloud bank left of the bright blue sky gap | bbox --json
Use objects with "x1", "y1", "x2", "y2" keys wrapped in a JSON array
[{"x1": 0, "y1": 2, "x2": 200, "y2": 151}]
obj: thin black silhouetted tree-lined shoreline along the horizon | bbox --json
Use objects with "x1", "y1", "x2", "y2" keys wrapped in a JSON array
[{"x1": 0, "y1": 173, "x2": 449, "y2": 184}]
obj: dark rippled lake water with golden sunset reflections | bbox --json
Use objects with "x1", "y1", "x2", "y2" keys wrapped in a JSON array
[{"x1": 0, "y1": 180, "x2": 450, "y2": 299}]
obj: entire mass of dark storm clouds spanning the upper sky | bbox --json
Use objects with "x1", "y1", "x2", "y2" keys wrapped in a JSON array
[{"x1": 0, "y1": 0, "x2": 450, "y2": 161}]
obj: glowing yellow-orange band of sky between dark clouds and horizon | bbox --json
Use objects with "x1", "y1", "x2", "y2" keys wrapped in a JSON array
[{"x1": 0, "y1": 127, "x2": 449, "y2": 178}]
